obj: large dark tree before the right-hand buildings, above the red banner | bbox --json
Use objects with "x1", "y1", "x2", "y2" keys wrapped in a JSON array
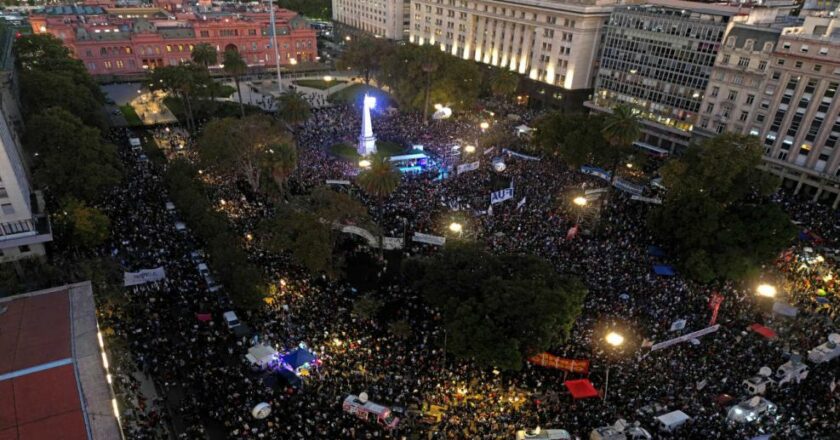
[{"x1": 649, "y1": 134, "x2": 795, "y2": 282}]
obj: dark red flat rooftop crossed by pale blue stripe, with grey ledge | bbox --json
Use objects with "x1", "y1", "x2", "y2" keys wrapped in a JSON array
[{"x1": 0, "y1": 282, "x2": 120, "y2": 440}]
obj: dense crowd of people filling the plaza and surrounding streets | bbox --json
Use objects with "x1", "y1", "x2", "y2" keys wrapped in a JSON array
[{"x1": 95, "y1": 97, "x2": 840, "y2": 439}]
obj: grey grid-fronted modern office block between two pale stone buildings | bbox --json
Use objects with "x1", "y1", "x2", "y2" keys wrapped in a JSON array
[{"x1": 586, "y1": 0, "x2": 739, "y2": 152}]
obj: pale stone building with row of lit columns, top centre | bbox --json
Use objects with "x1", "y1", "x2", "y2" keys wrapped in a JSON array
[{"x1": 409, "y1": 0, "x2": 620, "y2": 90}]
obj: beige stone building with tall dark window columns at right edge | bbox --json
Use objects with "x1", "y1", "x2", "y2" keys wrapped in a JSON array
[{"x1": 748, "y1": 14, "x2": 840, "y2": 207}]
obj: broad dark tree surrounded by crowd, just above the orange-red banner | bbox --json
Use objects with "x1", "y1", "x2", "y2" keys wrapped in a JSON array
[{"x1": 404, "y1": 242, "x2": 587, "y2": 370}]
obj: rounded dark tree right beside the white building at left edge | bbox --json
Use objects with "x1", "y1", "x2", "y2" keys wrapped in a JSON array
[{"x1": 24, "y1": 107, "x2": 122, "y2": 202}]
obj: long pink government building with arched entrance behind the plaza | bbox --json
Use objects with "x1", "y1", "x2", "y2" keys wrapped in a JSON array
[{"x1": 30, "y1": 0, "x2": 318, "y2": 75}]
